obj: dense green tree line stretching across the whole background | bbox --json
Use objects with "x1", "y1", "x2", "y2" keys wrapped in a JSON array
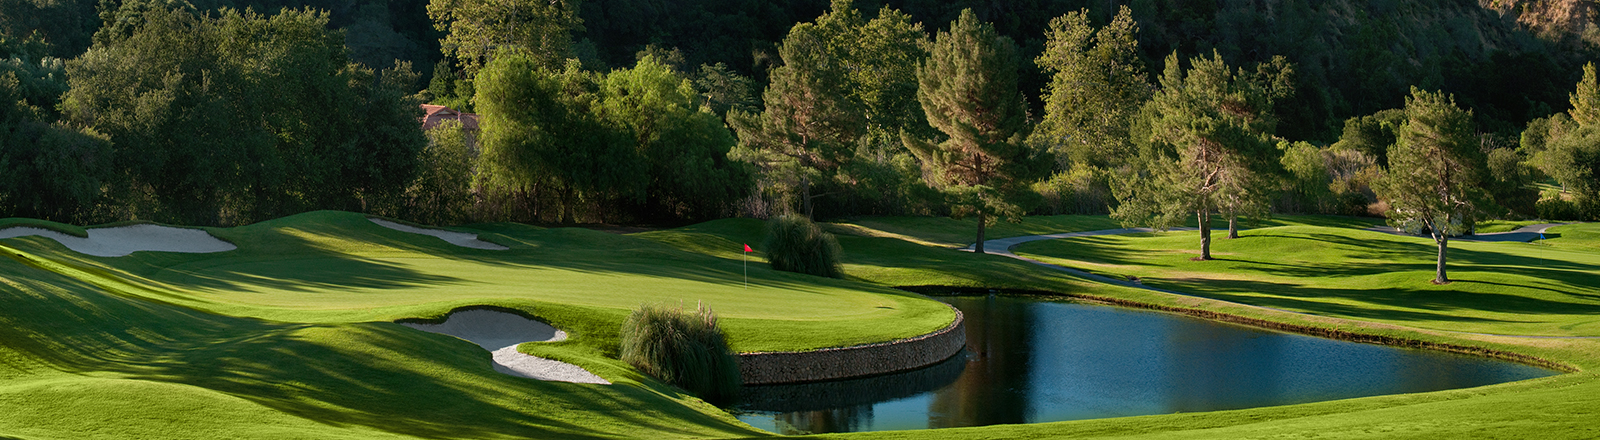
[{"x1": 0, "y1": 0, "x2": 1600, "y2": 241}]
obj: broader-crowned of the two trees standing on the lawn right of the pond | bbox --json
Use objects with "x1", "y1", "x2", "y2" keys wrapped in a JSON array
[{"x1": 1112, "y1": 53, "x2": 1290, "y2": 261}]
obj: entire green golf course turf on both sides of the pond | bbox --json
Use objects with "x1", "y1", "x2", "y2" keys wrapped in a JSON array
[{"x1": 0, "y1": 211, "x2": 1600, "y2": 438}]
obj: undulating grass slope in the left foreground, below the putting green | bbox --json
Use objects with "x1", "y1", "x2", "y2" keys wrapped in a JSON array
[{"x1": 0, "y1": 241, "x2": 757, "y2": 438}]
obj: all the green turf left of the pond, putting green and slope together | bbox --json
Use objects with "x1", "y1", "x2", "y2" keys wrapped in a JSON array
[{"x1": 0, "y1": 213, "x2": 950, "y2": 438}]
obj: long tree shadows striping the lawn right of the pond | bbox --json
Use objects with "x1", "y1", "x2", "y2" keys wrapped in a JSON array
[{"x1": 1024, "y1": 230, "x2": 1600, "y2": 323}]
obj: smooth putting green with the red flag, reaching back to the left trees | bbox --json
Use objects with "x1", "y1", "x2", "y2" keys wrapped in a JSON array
[{"x1": 9, "y1": 211, "x2": 954, "y2": 352}]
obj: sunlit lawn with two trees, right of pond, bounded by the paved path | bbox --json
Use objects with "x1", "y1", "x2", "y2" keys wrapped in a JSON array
[{"x1": 1016, "y1": 226, "x2": 1600, "y2": 336}]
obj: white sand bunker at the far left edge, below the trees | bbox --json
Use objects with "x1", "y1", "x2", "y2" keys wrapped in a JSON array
[{"x1": 0, "y1": 224, "x2": 238, "y2": 256}]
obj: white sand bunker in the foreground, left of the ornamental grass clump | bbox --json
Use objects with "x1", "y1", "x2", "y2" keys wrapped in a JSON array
[{"x1": 400, "y1": 310, "x2": 611, "y2": 386}]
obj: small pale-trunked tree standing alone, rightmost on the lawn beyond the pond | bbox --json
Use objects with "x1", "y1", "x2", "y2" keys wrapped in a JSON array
[{"x1": 1374, "y1": 88, "x2": 1486, "y2": 285}]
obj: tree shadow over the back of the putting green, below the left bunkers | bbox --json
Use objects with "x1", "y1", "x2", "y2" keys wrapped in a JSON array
[{"x1": 34, "y1": 213, "x2": 861, "y2": 301}]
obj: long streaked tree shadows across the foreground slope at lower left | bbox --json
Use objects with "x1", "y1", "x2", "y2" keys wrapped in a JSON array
[{"x1": 0, "y1": 258, "x2": 757, "y2": 438}]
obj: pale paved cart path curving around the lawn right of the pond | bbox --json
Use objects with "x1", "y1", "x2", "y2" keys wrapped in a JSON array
[{"x1": 963, "y1": 222, "x2": 1600, "y2": 344}]
